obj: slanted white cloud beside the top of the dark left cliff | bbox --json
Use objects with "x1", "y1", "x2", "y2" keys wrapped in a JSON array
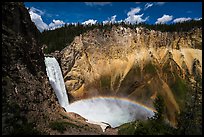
[{"x1": 29, "y1": 9, "x2": 48, "y2": 32}]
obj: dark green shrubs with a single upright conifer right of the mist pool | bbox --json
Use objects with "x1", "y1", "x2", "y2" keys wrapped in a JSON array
[{"x1": 118, "y1": 95, "x2": 174, "y2": 135}]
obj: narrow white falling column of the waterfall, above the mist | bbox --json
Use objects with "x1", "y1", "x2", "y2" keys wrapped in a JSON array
[{"x1": 45, "y1": 57, "x2": 69, "y2": 112}]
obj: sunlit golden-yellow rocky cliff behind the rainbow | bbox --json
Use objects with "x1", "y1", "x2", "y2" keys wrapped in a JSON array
[{"x1": 60, "y1": 26, "x2": 202, "y2": 125}]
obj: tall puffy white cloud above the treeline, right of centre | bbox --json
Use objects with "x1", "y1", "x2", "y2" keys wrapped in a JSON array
[{"x1": 124, "y1": 7, "x2": 149, "y2": 24}]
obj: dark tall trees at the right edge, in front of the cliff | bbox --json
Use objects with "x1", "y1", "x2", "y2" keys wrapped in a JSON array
[{"x1": 177, "y1": 71, "x2": 202, "y2": 135}]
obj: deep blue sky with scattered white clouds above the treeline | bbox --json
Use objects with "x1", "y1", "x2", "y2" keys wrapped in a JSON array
[{"x1": 24, "y1": 2, "x2": 202, "y2": 31}]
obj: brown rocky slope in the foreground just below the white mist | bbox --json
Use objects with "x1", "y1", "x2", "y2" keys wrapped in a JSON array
[{"x1": 50, "y1": 112, "x2": 118, "y2": 135}]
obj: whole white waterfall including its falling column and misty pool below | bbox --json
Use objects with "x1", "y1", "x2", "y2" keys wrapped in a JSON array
[{"x1": 45, "y1": 57, "x2": 154, "y2": 131}]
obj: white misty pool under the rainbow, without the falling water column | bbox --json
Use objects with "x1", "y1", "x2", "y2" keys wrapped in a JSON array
[{"x1": 69, "y1": 97, "x2": 154, "y2": 128}]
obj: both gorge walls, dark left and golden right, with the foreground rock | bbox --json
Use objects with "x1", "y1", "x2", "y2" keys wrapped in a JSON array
[{"x1": 2, "y1": 2, "x2": 202, "y2": 135}]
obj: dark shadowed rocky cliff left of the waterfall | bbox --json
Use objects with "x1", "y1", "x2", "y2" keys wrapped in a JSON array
[{"x1": 2, "y1": 2, "x2": 60, "y2": 135}]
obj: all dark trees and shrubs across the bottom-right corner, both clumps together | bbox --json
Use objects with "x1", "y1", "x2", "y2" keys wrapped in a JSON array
[{"x1": 118, "y1": 84, "x2": 202, "y2": 135}]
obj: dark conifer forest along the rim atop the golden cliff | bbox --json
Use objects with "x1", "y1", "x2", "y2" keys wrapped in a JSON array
[{"x1": 40, "y1": 19, "x2": 202, "y2": 53}]
